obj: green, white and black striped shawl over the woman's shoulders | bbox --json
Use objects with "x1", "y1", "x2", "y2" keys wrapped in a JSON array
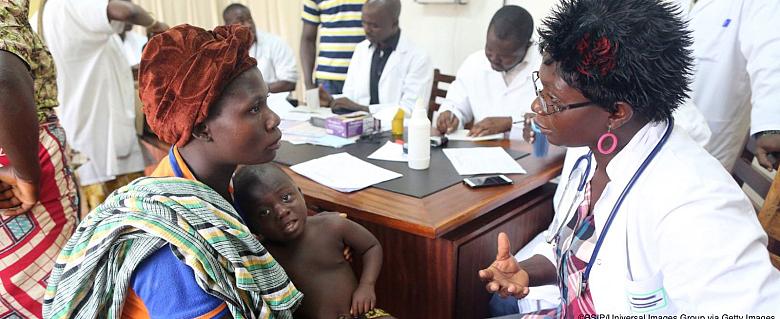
[{"x1": 43, "y1": 177, "x2": 303, "y2": 319}]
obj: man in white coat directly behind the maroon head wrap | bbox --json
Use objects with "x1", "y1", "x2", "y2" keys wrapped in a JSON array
[{"x1": 227, "y1": 3, "x2": 298, "y2": 93}]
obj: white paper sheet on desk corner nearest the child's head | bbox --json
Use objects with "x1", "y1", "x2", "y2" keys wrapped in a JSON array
[{"x1": 290, "y1": 153, "x2": 403, "y2": 193}]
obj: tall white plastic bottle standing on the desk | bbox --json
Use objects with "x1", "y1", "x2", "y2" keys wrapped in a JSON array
[{"x1": 407, "y1": 98, "x2": 431, "y2": 170}]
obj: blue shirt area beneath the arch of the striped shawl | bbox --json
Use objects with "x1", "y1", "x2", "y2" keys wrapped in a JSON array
[{"x1": 130, "y1": 245, "x2": 229, "y2": 319}]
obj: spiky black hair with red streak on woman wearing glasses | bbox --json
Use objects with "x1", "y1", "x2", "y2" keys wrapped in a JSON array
[{"x1": 539, "y1": 0, "x2": 693, "y2": 122}]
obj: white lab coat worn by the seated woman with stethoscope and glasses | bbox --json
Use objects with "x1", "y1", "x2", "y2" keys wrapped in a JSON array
[{"x1": 531, "y1": 124, "x2": 780, "y2": 315}]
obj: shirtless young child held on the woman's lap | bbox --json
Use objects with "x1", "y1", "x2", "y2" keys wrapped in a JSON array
[{"x1": 233, "y1": 164, "x2": 389, "y2": 319}]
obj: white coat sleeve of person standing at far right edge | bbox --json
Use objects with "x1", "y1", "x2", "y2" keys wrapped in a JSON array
[{"x1": 736, "y1": 0, "x2": 780, "y2": 135}]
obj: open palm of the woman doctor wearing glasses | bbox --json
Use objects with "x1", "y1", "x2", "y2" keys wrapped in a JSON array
[{"x1": 479, "y1": 233, "x2": 528, "y2": 299}]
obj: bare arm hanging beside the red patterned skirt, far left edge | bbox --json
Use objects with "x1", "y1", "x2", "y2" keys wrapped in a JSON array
[{"x1": 0, "y1": 50, "x2": 41, "y2": 215}]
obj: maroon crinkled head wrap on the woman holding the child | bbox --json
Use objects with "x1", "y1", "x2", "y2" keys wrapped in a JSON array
[{"x1": 138, "y1": 24, "x2": 257, "y2": 146}]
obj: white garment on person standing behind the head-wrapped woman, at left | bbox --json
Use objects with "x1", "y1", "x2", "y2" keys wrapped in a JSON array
[{"x1": 43, "y1": 0, "x2": 144, "y2": 185}]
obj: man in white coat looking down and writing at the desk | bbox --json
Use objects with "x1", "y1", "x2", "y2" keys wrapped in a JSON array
[{"x1": 436, "y1": 6, "x2": 542, "y2": 136}]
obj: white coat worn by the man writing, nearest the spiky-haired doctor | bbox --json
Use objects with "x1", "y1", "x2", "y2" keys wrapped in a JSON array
[{"x1": 439, "y1": 45, "x2": 542, "y2": 128}]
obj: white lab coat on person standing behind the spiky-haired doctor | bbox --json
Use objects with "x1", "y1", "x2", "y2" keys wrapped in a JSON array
[{"x1": 679, "y1": 0, "x2": 780, "y2": 169}]
